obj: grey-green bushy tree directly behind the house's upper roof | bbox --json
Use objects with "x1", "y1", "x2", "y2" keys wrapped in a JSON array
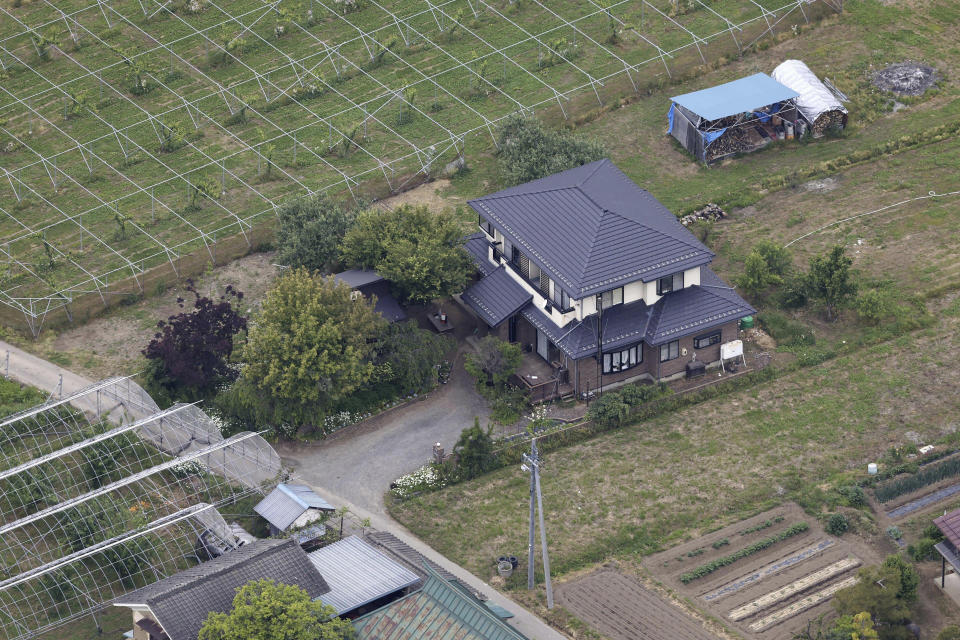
[{"x1": 497, "y1": 115, "x2": 607, "y2": 185}]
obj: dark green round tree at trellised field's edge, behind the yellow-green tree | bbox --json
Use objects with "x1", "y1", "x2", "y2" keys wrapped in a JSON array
[{"x1": 277, "y1": 193, "x2": 357, "y2": 272}]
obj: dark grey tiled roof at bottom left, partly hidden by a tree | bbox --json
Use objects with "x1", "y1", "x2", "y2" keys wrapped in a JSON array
[{"x1": 113, "y1": 540, "x2": 330, "y2": 640}]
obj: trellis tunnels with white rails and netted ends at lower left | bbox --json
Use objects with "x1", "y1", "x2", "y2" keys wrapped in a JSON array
[{"x1": 0, "y1": 378, "x2": 282, "y2": 640}]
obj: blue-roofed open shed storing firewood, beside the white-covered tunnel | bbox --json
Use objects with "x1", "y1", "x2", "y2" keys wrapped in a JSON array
[{"x1": 667, "y1": 73, "x2": 799, "y2": 163}]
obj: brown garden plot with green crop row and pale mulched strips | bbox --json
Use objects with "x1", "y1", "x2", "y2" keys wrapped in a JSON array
[{"x1": 643, "y1": 503, "x2": 879, "y2": 638}]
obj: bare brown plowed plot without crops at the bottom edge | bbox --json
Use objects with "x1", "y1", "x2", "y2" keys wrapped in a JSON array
[{"x1": 557, "y1": 569, "x2": 717, "y2": 640}]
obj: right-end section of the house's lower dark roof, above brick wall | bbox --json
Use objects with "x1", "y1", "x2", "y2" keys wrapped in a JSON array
[{"x1": 644, "y1": 267, "x2": 756, "y2": 345}]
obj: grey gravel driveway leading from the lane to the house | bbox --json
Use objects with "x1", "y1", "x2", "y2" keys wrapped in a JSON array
[{"x1": 275, "y1": 352, "x2": 490, "y2": 514}]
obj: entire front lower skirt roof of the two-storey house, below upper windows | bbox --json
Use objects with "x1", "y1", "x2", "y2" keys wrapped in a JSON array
[{"x1": 521, "y1": 267, "x2": 756, "y2": 360}]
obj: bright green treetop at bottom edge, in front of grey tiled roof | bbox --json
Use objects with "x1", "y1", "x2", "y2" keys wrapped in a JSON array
[{"x1": 199, "y1": 580, "x2": 356, "y2": 640}]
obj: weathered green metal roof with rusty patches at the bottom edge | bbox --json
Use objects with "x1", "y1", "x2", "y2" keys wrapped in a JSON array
[{"x1": 353, "y1": 574, "x2": 526, "y2": 640}]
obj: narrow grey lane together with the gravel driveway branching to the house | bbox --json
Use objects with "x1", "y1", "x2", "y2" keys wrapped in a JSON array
[{"x1": 0, "y1": 341, "x2": 566, "y2": 640}]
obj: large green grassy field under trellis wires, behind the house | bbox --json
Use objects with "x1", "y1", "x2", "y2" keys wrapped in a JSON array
[{"x1": 0, "y1": 0, "x2": 830, "y2": 332}]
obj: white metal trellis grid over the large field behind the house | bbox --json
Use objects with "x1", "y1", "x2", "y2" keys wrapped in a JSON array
[{"x1": 0, "y1": 0, "x2": 842, "y2": 336}]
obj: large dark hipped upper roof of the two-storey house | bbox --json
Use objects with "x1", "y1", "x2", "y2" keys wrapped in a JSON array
[{"x1": 468, "y1": 160, "x2": 713, "y2": 298}]
